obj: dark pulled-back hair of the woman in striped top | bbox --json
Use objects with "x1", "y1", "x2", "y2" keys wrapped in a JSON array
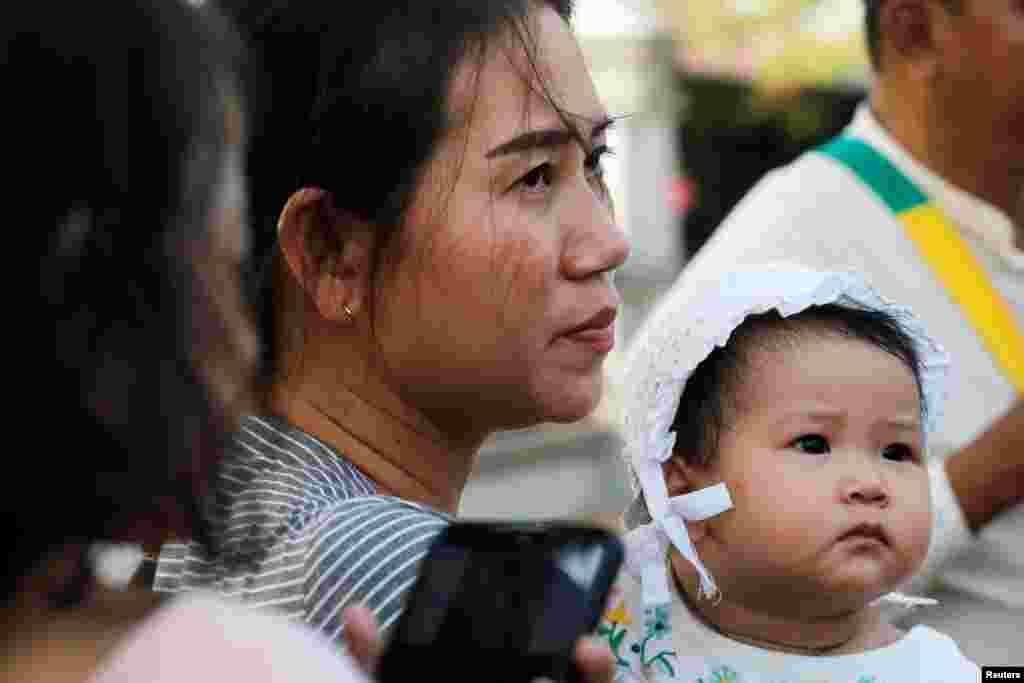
[{"x1": 219, "y1": 0, "x2": 578, "y2": 387}]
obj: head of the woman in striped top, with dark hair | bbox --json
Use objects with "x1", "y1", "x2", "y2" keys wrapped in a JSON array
[{"x1": 234, "y1": 0, "x2": 628, "y2": 454}]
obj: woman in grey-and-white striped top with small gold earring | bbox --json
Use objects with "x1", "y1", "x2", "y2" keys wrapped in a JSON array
[{"x1": 156, "y1": 0, "x2": 628, "y2": 659}]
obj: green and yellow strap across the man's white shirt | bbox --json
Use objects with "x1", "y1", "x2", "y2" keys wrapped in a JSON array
[{"x1": 818, "y1": 136, "x2": 1024, "y2": 393}]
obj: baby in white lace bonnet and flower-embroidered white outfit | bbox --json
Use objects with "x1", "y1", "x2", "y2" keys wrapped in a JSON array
[{"x1": 599, "y1": 265, "x2": 980, "y2": 683}]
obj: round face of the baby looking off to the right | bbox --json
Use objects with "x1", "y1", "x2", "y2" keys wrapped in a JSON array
[{"x1": 698, "y1": 335, "x2": 931, "y2": 618}]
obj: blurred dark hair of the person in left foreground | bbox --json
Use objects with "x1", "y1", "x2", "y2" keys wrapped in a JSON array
[{"x1": 0, "y1": 0, "x2": 237, "y2": 602}]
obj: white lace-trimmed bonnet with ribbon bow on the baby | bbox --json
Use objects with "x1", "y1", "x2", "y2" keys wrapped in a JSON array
[{"x1": 622, "y1": 263, "x2": 949, "y2": 606}]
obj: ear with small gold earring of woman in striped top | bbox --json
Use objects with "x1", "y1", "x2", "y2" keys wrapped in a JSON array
[{"x1": 278, "y1": 187, "x2": 374, "y2": 323}]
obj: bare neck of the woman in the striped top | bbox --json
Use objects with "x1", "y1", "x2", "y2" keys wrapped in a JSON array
[{"x1": 270, "y1": 356, "x2": 486, "y2": 514}]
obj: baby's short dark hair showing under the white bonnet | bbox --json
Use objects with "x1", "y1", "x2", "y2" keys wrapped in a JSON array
[{"x1": 671, "y1": 304, "x2": 924, "y2": 465}]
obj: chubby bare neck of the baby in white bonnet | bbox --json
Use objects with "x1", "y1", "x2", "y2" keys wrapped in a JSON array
[{"x1": 671, "y1": 552, "x2": 902, "y2": 656}]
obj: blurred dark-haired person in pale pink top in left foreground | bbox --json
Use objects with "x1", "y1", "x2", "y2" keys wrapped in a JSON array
[{"x1": 0, "y1": 0, "x2": 372, "y2": 683}]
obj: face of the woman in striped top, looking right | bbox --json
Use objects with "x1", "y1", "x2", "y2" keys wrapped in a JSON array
[{"x1": 375, "y1": 3, "x2": 629, "y2": 430}]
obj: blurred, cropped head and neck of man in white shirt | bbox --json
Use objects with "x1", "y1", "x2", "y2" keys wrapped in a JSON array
[{"x1": 865, "y1": 0, "x2": 1024, "y2": 215}]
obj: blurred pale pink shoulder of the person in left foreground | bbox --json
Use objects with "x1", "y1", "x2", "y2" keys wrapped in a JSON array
[{"x1": 91, "y1": 592, "x2": 367, "y2": 683}]
